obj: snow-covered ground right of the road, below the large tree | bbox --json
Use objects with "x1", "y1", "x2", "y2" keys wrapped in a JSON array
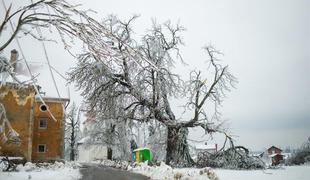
[{"x1": 128, "y1": 163, "x2": 310, "y2": 180}]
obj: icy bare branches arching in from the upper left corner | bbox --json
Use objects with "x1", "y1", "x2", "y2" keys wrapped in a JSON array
[{"x1": 0, "y1": 0, "x2": 155, "y2": 67}]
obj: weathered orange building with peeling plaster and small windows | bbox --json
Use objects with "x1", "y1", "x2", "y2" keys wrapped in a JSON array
[{"x1": 0, "y1": 83, "x2": 68, "y2": 161}]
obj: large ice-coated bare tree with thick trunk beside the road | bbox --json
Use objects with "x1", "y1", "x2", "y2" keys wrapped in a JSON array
[{"x1": 69, "y1": 16, "x2": 236, "y2": 166}]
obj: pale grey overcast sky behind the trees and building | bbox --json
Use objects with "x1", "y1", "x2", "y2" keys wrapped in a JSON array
[{"x1": 1, "y1": 0, "x2": 310, "y2": 150}]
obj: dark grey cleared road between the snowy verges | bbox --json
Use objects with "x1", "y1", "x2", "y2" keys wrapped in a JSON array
[{"x1": 80, "y1": 165, "x2": 149, "y2": 180}]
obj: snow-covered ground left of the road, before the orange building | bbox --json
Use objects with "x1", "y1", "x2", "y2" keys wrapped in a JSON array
[{"x1": 0, "y1": 162, "x2": 81, "y2": 180}]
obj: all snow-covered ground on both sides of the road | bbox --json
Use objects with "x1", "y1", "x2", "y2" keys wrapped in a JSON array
[{"x1": 0, "y1": 161, "x2": 310, "y2": 180}]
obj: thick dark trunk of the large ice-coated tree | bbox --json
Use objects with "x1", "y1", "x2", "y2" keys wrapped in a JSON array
[{"x1": 166, "y1": 126, "x2": 194, "y2": 167}]
